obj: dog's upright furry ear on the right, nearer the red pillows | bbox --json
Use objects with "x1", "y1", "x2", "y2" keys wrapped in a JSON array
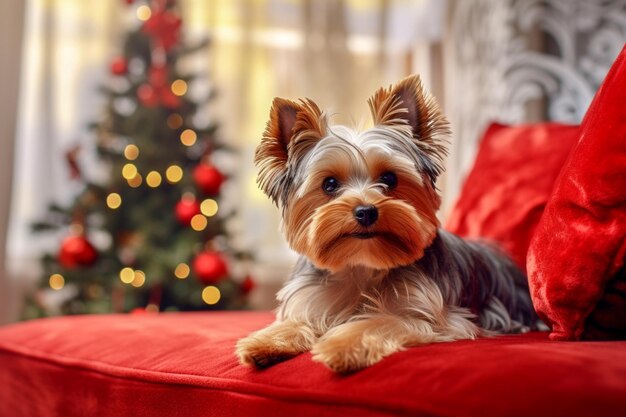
[{"x1": 368, "y1": 75, "x2": 450, "y2": 177}]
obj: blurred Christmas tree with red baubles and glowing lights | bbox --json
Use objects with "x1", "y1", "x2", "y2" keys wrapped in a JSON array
[{"x1": 24, "y1": 0, "x2": 252, "y2": 318}]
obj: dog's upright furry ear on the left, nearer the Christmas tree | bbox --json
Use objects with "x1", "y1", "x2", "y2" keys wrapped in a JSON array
[{"x1": 254, "y1": 97, "x2": 326, "y2": 203}]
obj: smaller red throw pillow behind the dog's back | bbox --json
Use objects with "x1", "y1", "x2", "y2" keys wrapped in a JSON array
[{"x1": 445, "y1": 123, "x2": 580, "y2": 270}]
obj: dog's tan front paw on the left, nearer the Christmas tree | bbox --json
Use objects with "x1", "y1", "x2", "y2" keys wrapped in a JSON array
[{"x1": 236, "y1": 322, "x2": 315, "y2": 368}]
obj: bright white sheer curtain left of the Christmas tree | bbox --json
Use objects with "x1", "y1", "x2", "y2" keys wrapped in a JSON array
[{"x1": 3, "y1": 0, "x2": 122, "y2": 310}]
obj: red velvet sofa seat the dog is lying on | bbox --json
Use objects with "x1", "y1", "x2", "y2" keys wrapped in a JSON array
[{"x1": 0, "y1": 312, "x2": 626, "y2": 417}]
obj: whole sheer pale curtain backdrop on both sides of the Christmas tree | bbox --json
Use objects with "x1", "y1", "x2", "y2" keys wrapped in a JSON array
[{"x1": 9, "y1": 0, "x2": 446, "y2": 312}]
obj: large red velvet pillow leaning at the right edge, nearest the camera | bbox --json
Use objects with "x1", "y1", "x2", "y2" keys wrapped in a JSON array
[{"x1": 527, "y1": 44, "x2": 626, "y2": 340}]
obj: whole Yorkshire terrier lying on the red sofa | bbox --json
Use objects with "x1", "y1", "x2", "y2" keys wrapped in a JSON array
[{"x1": 237, "y1": 76, "x2": 535, "y2": 373}]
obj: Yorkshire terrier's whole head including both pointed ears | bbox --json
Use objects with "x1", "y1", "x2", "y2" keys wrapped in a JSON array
[{"x1": 255, "y1": 76, "x2": 449, "y2": 271}]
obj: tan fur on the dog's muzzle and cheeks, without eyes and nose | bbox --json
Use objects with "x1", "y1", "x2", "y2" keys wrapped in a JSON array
[{"x1": 284, "y1": 154, "x2": 440, "y2": 271}]
